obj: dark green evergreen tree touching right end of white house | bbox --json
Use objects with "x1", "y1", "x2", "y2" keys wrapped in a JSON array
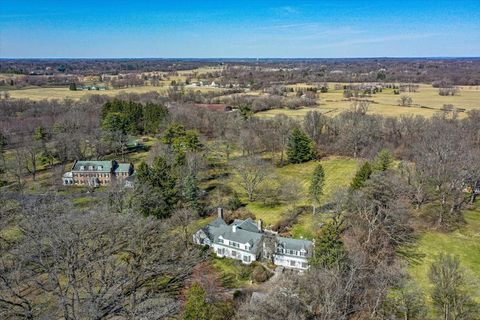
[{"x1": 310, "y1": 222, "x2": 346, "y2": 268}]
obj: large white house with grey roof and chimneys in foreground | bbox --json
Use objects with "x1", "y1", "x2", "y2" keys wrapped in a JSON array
[{"x1": 193, "y1": 208, "x2": 313, "y2": 270}]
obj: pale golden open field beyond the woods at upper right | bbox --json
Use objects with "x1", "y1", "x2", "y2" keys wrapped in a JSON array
[{"x1": 257, "y1": 84, "x2": 480, "y2": 117}]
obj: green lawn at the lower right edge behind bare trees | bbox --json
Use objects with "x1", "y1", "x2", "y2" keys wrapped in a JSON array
[{"x1": 408, "y1": 210, "x2": 480, "y2": 302}]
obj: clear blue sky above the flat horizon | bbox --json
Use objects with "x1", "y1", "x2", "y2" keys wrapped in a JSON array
[{"x1": 0, "y1": 0, "x2": 480, "y2": 58}]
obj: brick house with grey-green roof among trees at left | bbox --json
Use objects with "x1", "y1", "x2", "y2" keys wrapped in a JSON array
[{"x1": 62, "y1": 160, "x2": 134, "y2": 187}]
